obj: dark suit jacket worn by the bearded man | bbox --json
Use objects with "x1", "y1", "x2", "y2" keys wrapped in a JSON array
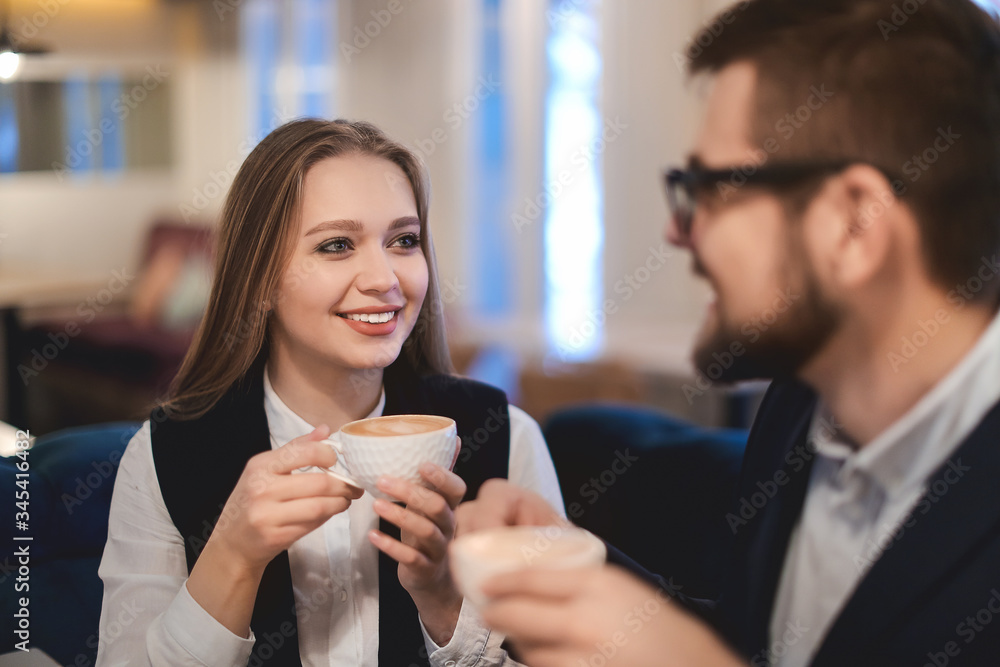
[{"x1": 611, "y1": 382, "x2": 1000, "y2": 667}]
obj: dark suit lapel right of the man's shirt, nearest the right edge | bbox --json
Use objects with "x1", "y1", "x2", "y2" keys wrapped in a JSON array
[{"x1": 816, "y1": 404, "x2": 1000, "y2": 664}]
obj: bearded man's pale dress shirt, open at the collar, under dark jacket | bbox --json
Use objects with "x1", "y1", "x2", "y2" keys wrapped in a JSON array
[{"x1": 768, "y1": 316, "x2": 1000, "y2": 667}]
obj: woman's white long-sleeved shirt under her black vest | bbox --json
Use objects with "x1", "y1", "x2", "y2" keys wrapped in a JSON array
[{"x1": 97, "y1": 374, "x2": 565, "y2": 667}]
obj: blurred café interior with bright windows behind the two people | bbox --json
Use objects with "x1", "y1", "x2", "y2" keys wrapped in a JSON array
[{"x1": 0, "y1": 0, "x2": 768, "y2": 435}]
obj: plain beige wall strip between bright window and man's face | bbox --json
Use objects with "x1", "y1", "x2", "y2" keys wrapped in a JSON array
[{"x1": 592, "y1": 0, "x2": 705, "y2": 370}]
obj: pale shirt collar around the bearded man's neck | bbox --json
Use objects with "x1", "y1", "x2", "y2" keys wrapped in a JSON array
[{"x1": 809, "y1": 308, "x2": 1000, "y2": 495}]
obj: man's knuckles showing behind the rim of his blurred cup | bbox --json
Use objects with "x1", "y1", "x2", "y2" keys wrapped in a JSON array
[{"x1": 455, "y1": 479, "x2": 568, "y2": 535}]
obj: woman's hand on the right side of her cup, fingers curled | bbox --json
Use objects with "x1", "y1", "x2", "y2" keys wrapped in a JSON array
[{"x1": 369, "y1": 463, "x2": 465, "y2": 646}]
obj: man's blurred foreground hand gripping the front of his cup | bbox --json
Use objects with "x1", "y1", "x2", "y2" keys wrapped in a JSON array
[{"x1": 483, "y1": 567, "x2": 745, "y2": 667}]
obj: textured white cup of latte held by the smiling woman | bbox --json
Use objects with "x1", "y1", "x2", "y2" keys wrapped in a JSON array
[{"x1": 323, "y1": 415, "x2": 456, "y2": 500}]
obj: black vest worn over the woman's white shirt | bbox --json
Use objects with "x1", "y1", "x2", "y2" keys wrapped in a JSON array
[{"x1": 150, "y1": 362, "x2": 510, "y2": 667}]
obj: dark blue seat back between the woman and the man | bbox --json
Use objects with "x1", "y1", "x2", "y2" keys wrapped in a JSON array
[{"x1": 543, "y1": 405, "x2": 747, "y2": 599}]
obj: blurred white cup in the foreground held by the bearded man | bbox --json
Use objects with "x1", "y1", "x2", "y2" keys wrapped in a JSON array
[{"x1": 450, "y1": 526, "x2": 608, "y2": 608}]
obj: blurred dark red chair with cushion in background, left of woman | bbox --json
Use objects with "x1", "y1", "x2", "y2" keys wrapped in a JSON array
[{"x1": 23, "y1": 221, "x2": 213, "y2": 434}]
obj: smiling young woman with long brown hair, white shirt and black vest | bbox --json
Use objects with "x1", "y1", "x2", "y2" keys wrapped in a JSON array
[{"x1": 98, "y1": 120, "x2": 562, "y2": 667}]
